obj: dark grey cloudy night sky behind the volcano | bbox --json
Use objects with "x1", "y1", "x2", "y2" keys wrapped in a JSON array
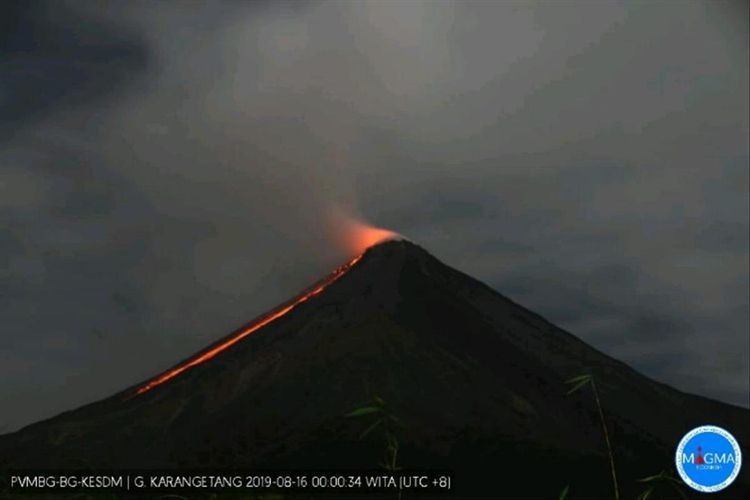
[{"x1": 0, "y1": 1, "x2": 750, "y2": 430}]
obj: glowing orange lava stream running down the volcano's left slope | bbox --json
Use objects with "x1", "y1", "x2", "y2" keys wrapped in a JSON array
[{"x1": 131, "y1": 253, "x2": 364, "y2": 397}]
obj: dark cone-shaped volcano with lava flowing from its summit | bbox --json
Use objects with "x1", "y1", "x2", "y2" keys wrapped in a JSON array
[{"x1": 0, "y1": 240, "x2": 750, "y2": 498}]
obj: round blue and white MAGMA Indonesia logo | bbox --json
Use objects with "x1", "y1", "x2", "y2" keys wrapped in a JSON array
[{"x1": 674, "y1": 425, "x2": 742, "y2": 493}]
